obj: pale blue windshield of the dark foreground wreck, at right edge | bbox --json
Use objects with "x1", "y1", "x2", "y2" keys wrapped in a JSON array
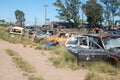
[{"x1": 103, "y1": 37, "x2": 120, "y2": 49}]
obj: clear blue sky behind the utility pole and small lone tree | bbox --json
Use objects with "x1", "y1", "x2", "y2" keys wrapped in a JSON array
[{"x1": 0, "y1": 0, "x2": 86, "y2": 25}]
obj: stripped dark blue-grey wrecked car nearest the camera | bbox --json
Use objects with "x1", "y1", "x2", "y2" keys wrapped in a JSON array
[{"x1": 66, "y1": 34, "x2": 120, "y2": 64}]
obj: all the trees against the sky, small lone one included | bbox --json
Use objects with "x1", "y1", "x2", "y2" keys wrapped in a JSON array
[{"x1": 15, "y1": 0, "x2": 120, "y2": 27}]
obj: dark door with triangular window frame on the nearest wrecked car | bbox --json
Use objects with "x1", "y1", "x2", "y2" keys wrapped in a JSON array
[{"x1": 78, "y1": 36, "x2": 107, "y2": 61}]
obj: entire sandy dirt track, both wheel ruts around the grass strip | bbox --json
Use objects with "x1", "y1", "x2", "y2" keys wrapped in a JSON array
[{"x1": 0, "y1": 40, "x2": 87, "y2": 80}]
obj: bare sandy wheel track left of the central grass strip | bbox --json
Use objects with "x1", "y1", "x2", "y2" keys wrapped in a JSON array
[{"x1": 0, "y1": 46, "x2": 26, "y2": 80}]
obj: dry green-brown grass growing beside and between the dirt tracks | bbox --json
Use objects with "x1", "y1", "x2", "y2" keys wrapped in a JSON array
[{"x1": 0, "y1": 26, "x2": 120, "y2": 80}]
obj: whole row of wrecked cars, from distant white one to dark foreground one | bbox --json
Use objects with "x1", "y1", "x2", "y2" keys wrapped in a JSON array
[{"x1": 10, "y1": 27, "x2": 120, "y2": 64}]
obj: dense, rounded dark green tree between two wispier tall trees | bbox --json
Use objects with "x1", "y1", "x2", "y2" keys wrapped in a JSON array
[{"x1": 82, "y1": 0, "x2": 103, "y2": 26}]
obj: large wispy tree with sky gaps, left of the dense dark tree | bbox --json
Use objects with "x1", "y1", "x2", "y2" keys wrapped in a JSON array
[{"x1": 54, "y1": 0, "x2": 81, "y2": 27}]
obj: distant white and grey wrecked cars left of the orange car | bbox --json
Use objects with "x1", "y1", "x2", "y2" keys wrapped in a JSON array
[{"x1": 10, "y1": 26, "x2": 55, "y2": 42}]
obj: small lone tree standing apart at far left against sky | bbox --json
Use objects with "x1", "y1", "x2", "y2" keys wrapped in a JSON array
[{"x1": 15, "y1": 10, "x2": 25, "y2": 26}]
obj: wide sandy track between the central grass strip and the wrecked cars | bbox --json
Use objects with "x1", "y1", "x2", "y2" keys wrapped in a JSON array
[{"x1": 0, "y1": 40, "x2": 87, "y2": 80}]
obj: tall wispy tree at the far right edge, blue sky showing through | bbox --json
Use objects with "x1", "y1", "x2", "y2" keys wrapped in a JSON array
[{"x1": 101, "y1": 0, "x2": 120, "y2": 26}]
